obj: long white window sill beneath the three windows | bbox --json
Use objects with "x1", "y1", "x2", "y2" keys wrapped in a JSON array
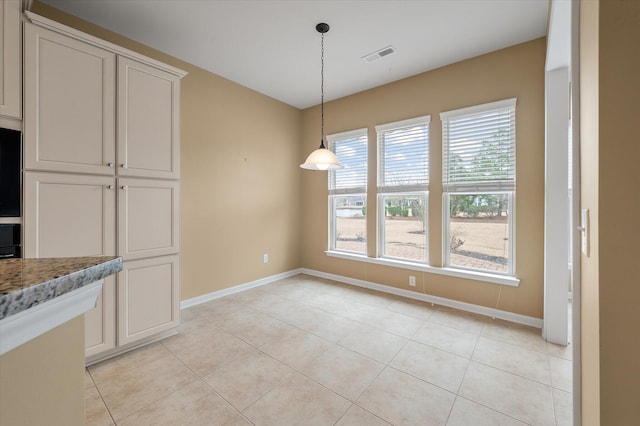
[{"x1": 325, "y1": 251, "x2": 520, "y2": 287}]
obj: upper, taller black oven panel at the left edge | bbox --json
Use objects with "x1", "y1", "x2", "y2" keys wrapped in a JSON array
[{"x1": 0, "y1": 128, "x2": 22, "y2": 217}]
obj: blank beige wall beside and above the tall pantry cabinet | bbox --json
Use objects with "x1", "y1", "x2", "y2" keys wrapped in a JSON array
[{"x1": 31, "y1": 2, "x2": 302, "y2": 300}]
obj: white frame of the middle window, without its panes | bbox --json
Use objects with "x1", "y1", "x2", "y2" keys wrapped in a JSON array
[{"x1": 375, "y1": 115, "x2": 431, "y2": 265}]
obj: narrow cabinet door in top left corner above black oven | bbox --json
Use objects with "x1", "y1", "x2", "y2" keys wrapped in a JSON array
[{"x1": 0, "y1": 0, "x2": 22, "y2": 118}]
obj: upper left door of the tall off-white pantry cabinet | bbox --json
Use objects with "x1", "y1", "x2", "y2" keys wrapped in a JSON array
[{"x1": 24, "y1": 23, "x2": 115, "y2": 175}]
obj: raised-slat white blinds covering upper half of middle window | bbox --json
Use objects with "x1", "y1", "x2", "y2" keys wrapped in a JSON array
[{"x1": 376, "y1": 116, "x2": 430, "y2": 192}]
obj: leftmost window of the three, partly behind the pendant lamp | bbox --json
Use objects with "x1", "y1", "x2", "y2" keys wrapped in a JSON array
[{"x1": 327, "y1": 129, "x2": 368, "y2": 255}]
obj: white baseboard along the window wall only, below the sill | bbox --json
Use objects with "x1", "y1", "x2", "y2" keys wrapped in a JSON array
[{"x1": 301, "y1": 268, "x2": 542, "y2": 329}]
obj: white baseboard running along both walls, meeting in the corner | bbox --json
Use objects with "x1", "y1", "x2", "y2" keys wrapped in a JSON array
[{"x1": 180, "y1": 268, "x2": 542, "y2": 328}]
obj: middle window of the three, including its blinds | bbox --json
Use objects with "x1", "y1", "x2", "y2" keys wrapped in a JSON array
[{"x1": 376, "y1": 116, "x2": 430, "y2": 263}]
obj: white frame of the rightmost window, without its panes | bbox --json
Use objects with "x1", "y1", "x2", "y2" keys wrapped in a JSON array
[{"x1": 440, "y1": 98, "x2": 517, "y2": 278}]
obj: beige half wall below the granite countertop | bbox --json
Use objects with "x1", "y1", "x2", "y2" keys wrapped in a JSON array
[{"x1": 0, "y1": 316, "x2": 85, "y2": 426}]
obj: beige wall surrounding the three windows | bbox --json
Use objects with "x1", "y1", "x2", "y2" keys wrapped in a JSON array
[{"x1": 302, "y1": 38, "x2": 546, "y2": 318}]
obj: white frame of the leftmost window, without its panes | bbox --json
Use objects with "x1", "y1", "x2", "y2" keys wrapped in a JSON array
[{"x1": 326, "y1": 128, "x2": 369, "y2": 256}]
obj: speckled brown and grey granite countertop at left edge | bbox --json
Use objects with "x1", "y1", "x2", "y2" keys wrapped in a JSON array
[{"x1": 0, "y1": 256, "x2": 122, "y2": 320}]
